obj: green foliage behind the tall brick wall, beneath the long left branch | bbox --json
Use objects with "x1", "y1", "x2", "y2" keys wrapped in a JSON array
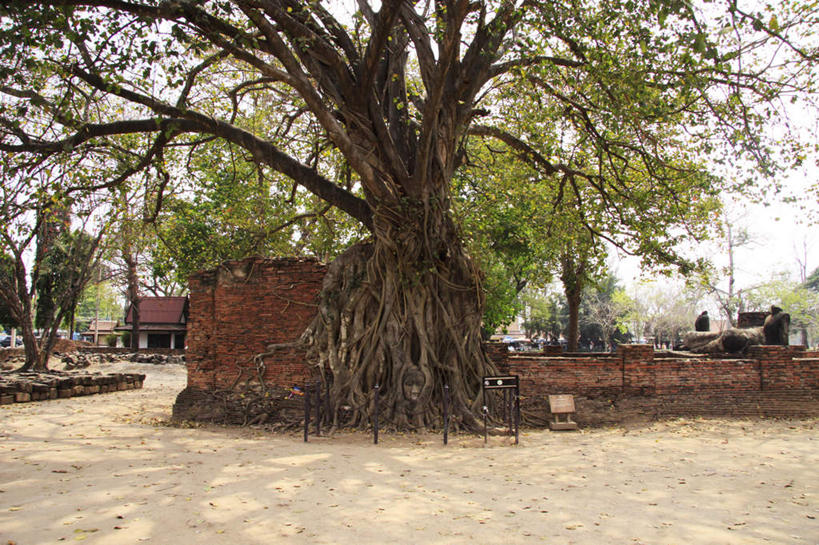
[{"x1": 151, "y1": 138, "x2": 362, "y2": 286}]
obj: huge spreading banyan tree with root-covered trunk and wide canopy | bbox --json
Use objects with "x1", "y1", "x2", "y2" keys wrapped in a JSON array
[{"x1": 0, "y1": 0, "x2": 816, "y2": 426}]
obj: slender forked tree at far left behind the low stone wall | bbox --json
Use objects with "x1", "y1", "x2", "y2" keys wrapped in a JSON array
[{"x1": 0, "y1": 170, "x2": 113, "y2": 370}]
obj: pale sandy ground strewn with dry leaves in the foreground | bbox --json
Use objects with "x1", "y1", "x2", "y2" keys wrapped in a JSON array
[{"x1": 0, "y1": 364, "x2": 819, "y2": 545}]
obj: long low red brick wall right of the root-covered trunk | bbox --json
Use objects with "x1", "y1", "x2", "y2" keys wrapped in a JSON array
[{"x1": 487, "y1": 345, "x2": 819, "y2": 425}]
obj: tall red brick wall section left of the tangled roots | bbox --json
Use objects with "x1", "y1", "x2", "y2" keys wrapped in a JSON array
[{"x1": 174, "y1": 258, "x2": 326, "y2": 420}]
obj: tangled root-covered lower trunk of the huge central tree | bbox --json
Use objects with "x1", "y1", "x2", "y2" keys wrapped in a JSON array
[{"x1": 303, "y1": 204, "x2": 496, "y2": 429}]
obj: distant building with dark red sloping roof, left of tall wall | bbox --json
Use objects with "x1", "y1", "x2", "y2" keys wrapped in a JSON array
[{"x1": 116, "y1": 297, "x2": 188, "y2": 349}]
